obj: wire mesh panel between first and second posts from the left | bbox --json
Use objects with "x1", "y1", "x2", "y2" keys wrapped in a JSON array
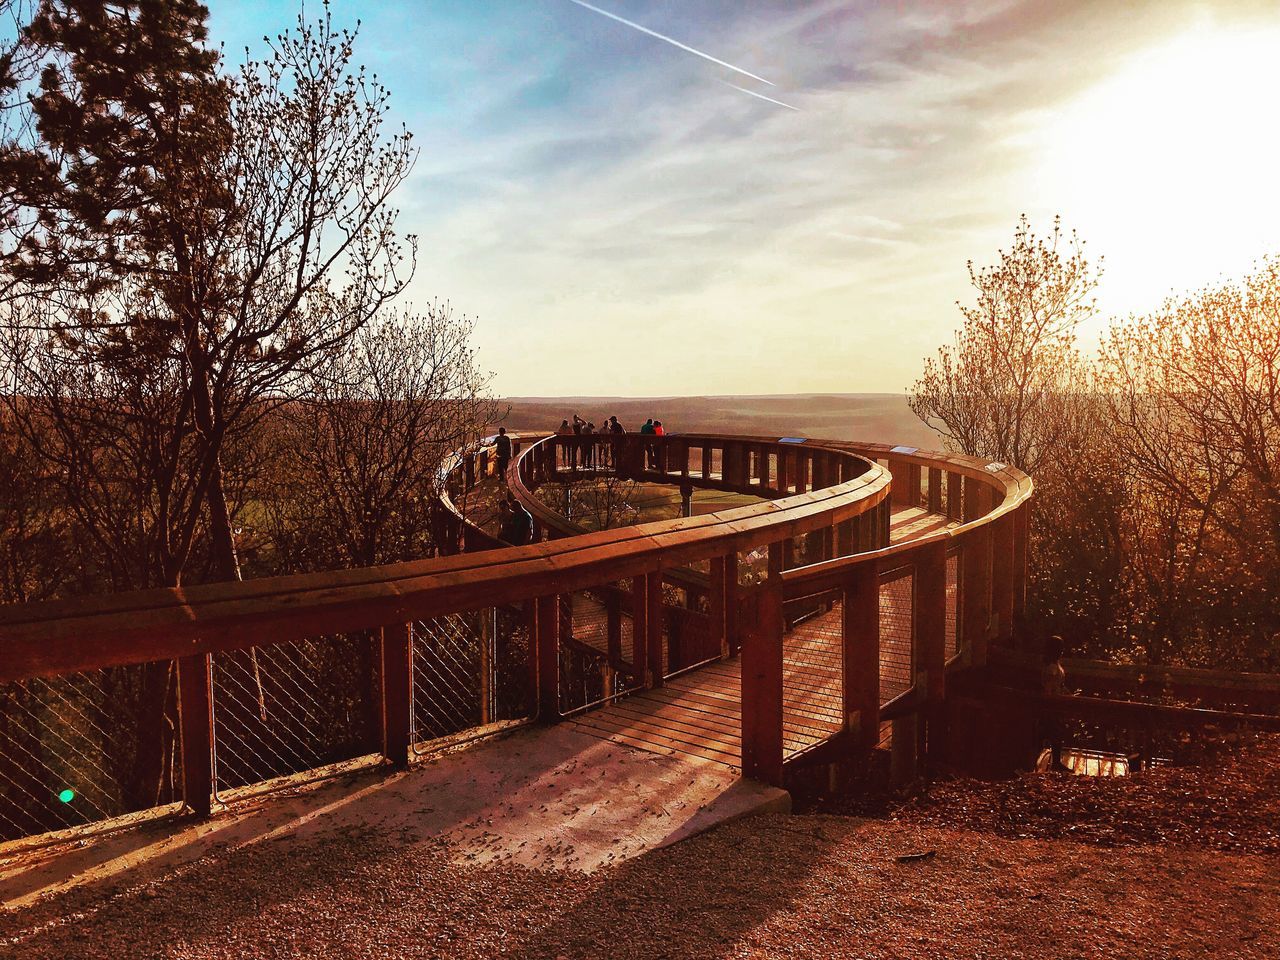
[{"x1": 212, "y1": 640, "x2": 381, "y2": 790}]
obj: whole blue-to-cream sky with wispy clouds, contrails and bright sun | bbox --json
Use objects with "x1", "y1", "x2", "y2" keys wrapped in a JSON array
[{"x1": 207, "y1": 0, "x2": 1280, "y2": 397}]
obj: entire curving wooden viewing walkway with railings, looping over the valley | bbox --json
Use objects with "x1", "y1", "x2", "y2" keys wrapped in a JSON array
[{"x1": 0, "y1": 434, "x2": 1032, "y2": 899}]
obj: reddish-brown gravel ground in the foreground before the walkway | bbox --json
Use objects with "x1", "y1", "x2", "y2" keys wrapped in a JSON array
[{"x1": 0, "y1": 815, "x2": 1280, "y2": 960}]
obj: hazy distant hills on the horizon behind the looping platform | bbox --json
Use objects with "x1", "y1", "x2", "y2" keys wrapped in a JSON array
[{"x1": 503, "y1": 393, "x2": 942, "y2": 449}]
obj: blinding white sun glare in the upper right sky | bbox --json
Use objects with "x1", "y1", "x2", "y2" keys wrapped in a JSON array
[{"x1": 1041, "y1": 27, "x2": 1280, "y2": 320}]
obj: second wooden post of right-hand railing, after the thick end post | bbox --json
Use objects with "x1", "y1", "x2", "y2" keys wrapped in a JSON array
[{"x1": 841, "y1": 561, "x2": 879, "y2": 759}]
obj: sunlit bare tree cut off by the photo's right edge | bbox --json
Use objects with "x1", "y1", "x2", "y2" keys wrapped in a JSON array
[{"x1": 1098, "y1": 259, "x2": 1280, "y2": 655}]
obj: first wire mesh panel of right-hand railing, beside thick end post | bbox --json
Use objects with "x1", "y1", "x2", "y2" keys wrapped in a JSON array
[{"x1": 782, "y1": 594, "x2": 844, "y2": 756}]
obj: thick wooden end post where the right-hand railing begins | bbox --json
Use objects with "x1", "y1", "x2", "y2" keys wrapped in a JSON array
[{"x1": 742, "y1": 544, "x2": 783, "y2": 786}]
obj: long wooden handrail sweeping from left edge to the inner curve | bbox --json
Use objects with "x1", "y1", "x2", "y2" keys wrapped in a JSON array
[{"x1": 0, "y1": 432, "x2": 890, "y2": 681}]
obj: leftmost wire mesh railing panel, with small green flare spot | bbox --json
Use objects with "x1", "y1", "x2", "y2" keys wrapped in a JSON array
[{"x1": 0, "y1": 660, "x2": 182, "y2": 841}]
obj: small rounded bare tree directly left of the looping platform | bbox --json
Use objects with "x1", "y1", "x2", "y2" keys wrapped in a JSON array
[{"x1": 261, "y1": 303, "x2": 497, "y2": 570}]
